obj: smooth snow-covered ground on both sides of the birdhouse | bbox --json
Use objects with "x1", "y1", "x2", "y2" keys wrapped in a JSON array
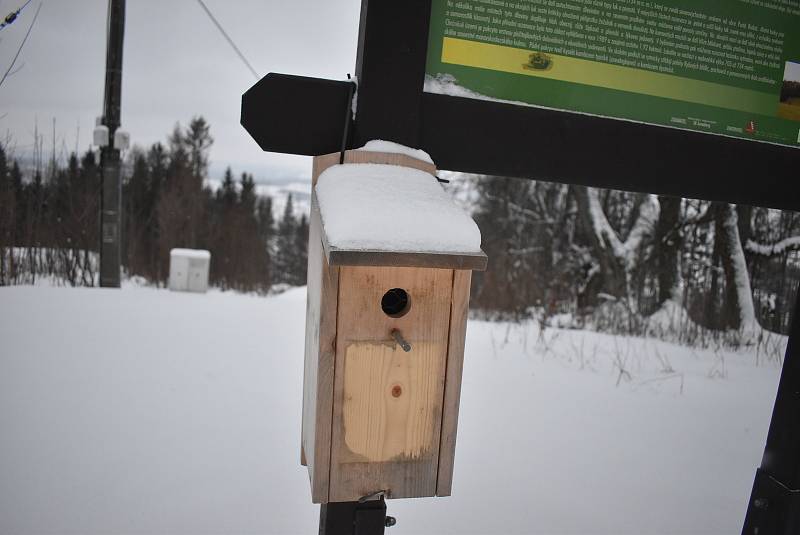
[{"x1": 0, "y1": 287, "x2": 780, "y2": 535}]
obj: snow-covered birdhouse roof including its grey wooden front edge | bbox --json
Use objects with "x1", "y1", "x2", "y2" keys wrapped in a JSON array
[{"x1": 315, "y1": 164, "x2": 486, "y2": 269}]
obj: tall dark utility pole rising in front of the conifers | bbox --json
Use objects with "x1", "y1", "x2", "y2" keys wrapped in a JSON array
[{"x1": 100, "y1": 0, "x2": 125, "y2": 288}]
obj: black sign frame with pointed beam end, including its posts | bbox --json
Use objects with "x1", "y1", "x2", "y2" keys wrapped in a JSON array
[{"x1": 241, "y1": 0, "x2": 800, "y2": 535}]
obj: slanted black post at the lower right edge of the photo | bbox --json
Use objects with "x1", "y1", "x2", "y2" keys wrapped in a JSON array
[{"x1": 742, "y1": 292, "x2": 800, "y2": 535}]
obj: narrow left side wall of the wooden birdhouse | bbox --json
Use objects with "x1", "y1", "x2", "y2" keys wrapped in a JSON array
[{"x1": 301, "y1": 184, "x2": 339, "y2": 503}]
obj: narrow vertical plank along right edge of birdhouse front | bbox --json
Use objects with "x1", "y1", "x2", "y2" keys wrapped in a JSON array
[{"x1": 436, "y1": 270, "x2": 472, "y2": 496}]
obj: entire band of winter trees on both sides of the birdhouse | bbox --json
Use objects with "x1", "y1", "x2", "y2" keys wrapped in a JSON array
[{"x1": 0, "y1": 118, "x2": 800, "y2": 348}]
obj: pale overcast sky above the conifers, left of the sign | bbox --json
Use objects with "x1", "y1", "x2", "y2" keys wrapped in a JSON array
[{"x1": 0, "y1": 0, "x2": 361, "y2": 179}]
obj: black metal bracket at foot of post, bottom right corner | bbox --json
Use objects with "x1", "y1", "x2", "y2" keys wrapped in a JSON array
[{"x1": 742, "y1": 469, "x2": 800, "y2": 535}]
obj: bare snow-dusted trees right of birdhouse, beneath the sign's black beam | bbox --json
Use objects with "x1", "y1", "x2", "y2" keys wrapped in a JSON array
[{"x1": 473, "y1": 177, "x2": 800, "y2": 344}]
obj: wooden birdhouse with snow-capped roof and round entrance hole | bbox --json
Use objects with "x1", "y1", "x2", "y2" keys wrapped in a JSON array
[{"x1": 301, "y1": 145, "x2": 487, "y2": 503}]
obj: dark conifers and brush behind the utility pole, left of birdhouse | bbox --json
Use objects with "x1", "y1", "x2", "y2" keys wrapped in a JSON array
[{"x1": 0, "y1": 117, "x2": 308, "y2": 293}]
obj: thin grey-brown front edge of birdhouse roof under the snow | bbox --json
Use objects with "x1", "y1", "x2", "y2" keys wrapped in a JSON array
[{"x1": 323, "y1": 247, "x2": 488, "y2": 271}]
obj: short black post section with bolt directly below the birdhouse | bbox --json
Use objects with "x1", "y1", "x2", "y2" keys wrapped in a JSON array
[{"x1": 319, "y1": 495, "x2": 397, "y2": 535}]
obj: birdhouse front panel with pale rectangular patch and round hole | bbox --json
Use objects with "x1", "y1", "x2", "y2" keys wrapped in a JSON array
[{"x1": 329, "y1": 266, "x2": 453, "y2": 502}]
